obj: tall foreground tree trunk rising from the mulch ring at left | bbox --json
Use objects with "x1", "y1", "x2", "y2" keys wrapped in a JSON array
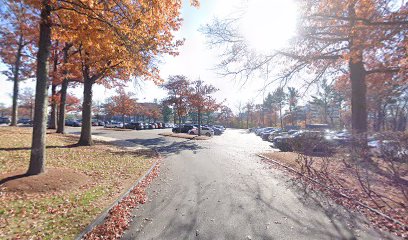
[{"x1": 27, "y1": 0, "x2": 51, "y2": 175}]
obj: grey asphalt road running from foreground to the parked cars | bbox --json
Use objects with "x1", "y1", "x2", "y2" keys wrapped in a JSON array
[{"x1": 69, "y1": 128, "x2": 396, "y2": 240}]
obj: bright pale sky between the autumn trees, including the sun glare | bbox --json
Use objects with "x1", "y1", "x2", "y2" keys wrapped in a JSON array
[{"x1": 0, "y1": 0, "x2": 296, "y2": 111}]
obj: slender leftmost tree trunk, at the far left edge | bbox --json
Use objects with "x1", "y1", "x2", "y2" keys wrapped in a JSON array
[{"x1": 10, "y1": 35, "x2": 23, "y2": 126}]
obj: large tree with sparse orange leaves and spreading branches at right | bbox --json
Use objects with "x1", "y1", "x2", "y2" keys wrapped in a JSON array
[{"x1": 202, "y1": 0, "x2": 408, "y2": 133}]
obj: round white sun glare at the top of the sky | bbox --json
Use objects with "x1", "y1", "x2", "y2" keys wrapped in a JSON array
[{"x1": 241, "y1": 0, "x2": 297, "y2": 53}]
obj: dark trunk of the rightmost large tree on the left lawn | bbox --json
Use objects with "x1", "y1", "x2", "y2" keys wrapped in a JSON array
[{"x1": 78, "y1": 78, "x2": 93, "y2": 146}]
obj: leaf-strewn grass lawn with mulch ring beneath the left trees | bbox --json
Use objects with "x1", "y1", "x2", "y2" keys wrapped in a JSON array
[{"x1": 0, "y1": 127, "x2": 155, "y2": 239}]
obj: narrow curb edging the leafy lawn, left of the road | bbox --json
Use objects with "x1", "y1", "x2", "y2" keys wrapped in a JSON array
[{"x1": 75, "y1": 157, "x2": 161, "y2": 240}]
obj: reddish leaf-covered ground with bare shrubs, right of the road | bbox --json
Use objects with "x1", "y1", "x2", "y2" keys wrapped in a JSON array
[{"x1": 261, "y1": 152, "x2": 408, "y2": 238}]
